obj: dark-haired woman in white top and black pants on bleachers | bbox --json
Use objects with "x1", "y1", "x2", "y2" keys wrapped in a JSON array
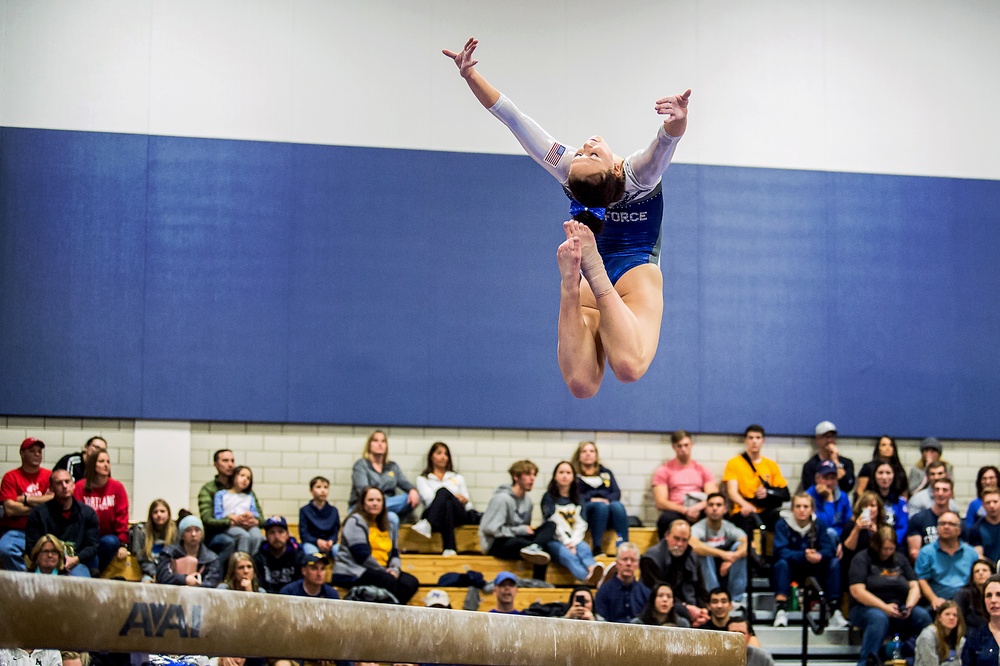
[{"x1": 412, "y1": 442, "x2": 472, "y2": 557}]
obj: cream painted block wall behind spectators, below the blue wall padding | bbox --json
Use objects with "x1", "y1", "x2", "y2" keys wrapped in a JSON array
[{"x1": 0, "y1": 417, "x2": 1000, "y2": 524}]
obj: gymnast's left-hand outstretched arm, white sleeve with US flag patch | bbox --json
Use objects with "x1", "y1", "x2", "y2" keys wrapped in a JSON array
[{"x1": 441, "y1": 37, "x2": 576, "y2": 185}]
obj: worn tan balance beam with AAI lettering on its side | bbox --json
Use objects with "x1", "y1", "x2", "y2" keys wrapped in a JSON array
[{"x1": 0, "y1": 572, "x2": 746, "y2": 666}]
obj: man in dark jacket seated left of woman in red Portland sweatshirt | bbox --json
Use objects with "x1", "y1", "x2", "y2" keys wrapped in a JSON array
[{"x1": 24, "y1": 469, "x2": 99, "y2": 578}]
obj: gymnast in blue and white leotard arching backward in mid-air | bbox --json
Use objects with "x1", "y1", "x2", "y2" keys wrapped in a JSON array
[{"x1": 442, "y1": 37, "x2": 691, "y2": 398}]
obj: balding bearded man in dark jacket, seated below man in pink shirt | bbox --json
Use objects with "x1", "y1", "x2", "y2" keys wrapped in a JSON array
[{"x1": 639, "y1": 519, "x2": 708, "y2": 627}]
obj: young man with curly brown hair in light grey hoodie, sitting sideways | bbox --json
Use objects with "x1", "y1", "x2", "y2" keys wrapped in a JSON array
[{"x1": 479, "y1": 460, "x2": 556, "y2": 580}]
